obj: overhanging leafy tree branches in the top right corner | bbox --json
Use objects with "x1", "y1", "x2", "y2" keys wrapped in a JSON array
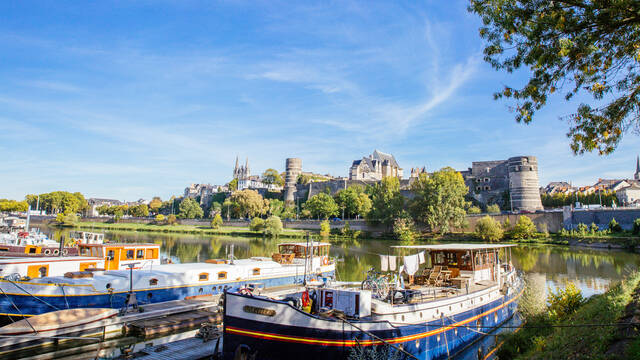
[{"x1": 469, "y1": 0, "x2": 640, "y2": 154}]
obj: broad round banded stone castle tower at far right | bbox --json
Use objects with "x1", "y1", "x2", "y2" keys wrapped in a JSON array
[{"x1": 507, "y1": 156, "x2": 543, "y2": 211}]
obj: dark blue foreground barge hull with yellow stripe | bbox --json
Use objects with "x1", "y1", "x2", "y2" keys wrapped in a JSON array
[{"x1": 223, "y1": 284, "x2": 522, "y2": 360}]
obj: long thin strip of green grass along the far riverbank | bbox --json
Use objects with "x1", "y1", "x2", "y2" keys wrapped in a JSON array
[{"x1": 75, "y1": 222, "x2": 306, "y2": 238}]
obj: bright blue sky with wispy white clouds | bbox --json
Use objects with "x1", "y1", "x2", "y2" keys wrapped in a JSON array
[{"x1": 0, "y1": 0, "x2": 639, "y2": 200}]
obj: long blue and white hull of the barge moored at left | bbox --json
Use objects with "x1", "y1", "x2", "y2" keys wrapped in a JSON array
[{"x1": 0, "y1": 271, "x2": 335, "y2": 321}]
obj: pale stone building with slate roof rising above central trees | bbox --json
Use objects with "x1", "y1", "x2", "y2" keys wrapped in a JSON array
[{"x1": 349, "y1": 150, "x2": 402, "y2": 181}]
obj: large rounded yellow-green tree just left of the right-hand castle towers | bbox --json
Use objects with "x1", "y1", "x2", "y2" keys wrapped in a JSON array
[{"x1": 410, "y1": 167, "x2": 469, "y2": 233}]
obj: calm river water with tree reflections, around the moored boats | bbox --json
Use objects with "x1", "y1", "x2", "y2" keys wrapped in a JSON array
[{"x1": 33, "y1": 228, "x2": 640, "y2": 359}]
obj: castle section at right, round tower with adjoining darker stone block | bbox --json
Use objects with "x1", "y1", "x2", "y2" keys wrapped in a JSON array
[{"x1": 460, "y1": 156, "x2": 542, "y2": 211}]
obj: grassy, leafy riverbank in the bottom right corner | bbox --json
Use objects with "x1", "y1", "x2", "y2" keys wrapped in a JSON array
[{"x1": 497, "y1": 273, "x2": 640, "y2": 359}]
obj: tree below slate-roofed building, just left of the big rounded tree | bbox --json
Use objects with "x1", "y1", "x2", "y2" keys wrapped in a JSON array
[{"x1": 367, "y1": 176, "x2": 405, "y2": 227}]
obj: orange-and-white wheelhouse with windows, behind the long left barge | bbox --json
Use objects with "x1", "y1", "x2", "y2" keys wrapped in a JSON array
[{"x1": 78, "y1": 243, "x2": 160, "y2": 270}]
